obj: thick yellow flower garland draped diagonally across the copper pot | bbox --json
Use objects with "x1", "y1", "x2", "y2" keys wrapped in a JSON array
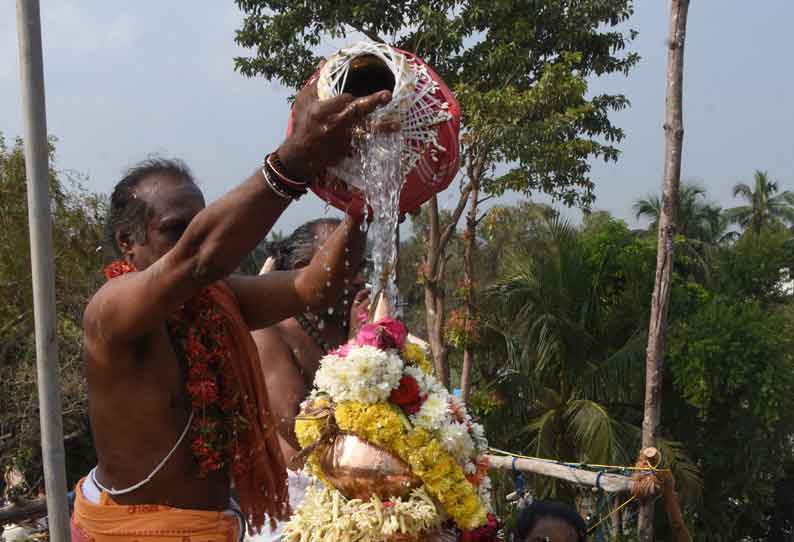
[{"x1": 332, "y1": 401, "x2": 487, "y2": 530}]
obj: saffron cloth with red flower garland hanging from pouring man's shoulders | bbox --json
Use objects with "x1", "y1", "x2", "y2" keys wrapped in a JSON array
[{"x1": 105, "y1": 261, "x2": 289, "y2": 530}]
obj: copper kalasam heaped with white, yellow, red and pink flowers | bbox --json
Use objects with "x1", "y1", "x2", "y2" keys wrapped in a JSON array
[{"x1": 284, "y1": 318, "x2": 498, "y2": 542}]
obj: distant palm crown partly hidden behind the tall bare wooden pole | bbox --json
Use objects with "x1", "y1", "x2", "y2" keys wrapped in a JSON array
[{"x1": 634, "y1": 183, "x2": 727, "y2": 245}]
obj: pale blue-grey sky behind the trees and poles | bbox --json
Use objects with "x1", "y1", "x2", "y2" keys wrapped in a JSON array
[{"x1": 0, "y1": 0, "x2": 794, "y2": 236}]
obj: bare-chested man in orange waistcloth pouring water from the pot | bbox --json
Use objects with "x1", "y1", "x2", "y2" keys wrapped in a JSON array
[{"x1": 72, "y1": 82, "x2": 390, "y2": 542}]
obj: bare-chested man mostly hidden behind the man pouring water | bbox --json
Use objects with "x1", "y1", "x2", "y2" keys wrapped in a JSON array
[{"x1": 248, "y1": 218, "x2": 369, "y2": 542}]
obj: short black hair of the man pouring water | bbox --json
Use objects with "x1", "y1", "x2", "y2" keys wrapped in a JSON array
[{"x1": 105, "y1": 157, "x2": 196, "y2": 258}]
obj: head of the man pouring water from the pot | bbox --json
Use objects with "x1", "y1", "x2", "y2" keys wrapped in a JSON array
[{"x1": 105, "y1": 158, "x2": 205, "y2": 270}]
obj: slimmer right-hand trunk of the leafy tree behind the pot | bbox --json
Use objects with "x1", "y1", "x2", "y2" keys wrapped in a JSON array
[{"x1": 460, "y1": 182, "x2": 480, "y2": 403}]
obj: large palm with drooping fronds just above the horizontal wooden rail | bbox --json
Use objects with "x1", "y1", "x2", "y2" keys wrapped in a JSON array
[{"x1": 488, "y1": 218, "x2": 696, "y2": 502}]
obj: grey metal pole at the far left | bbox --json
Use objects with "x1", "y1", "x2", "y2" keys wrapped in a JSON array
[{"x1": 17, "y1": 0, "x2": 69, "y2": 542}]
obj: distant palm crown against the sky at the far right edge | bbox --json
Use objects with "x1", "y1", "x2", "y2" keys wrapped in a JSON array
[{"x1": 725, "y1": 170, "x2": 794, "y2": 233}]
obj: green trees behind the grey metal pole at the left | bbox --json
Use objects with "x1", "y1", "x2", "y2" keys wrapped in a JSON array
[{"x1": 0, "y1": 134, "x2": 105, "y2": 498}]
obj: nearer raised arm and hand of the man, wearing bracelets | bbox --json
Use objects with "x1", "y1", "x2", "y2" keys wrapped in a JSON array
[{"x1": 84, "y1": 87, "x2": 390, "y2": 344}]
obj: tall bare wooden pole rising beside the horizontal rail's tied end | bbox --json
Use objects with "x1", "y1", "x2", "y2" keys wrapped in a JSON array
[{"x1": 638, "y1": 0, "x2": 689, "y2": 542}]
